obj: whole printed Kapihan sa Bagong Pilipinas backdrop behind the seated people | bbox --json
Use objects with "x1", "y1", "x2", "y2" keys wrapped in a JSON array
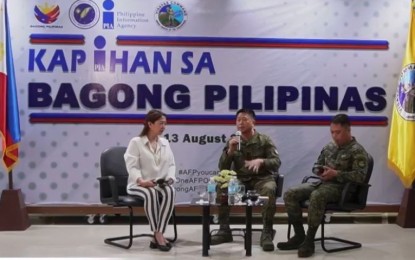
[{"x1": 0, "y1": 0, "x2": 410, "y2": 204}]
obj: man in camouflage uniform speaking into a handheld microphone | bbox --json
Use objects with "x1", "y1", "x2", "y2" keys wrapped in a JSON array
[{"x1": 211, "y1": 109, "x2": 281, "y2": 251}]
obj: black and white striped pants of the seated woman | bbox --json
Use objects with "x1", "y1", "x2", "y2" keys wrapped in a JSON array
[{"x1": 127, "y1": 185, "x2": 176, "y2": 233}]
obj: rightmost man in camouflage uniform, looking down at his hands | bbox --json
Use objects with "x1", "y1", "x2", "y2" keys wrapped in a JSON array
[{"x1": 277, "y1": 114, "x2": 368, "y2": 257}]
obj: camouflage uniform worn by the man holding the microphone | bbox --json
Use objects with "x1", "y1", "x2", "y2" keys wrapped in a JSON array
[{"x1": 218, "y1": 132, "x2": 281, "y2": 250}]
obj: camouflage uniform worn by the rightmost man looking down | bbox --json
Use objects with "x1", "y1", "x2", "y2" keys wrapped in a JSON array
[{"x1": 284, "y1": 137, "x2": 368, "y2": 227}]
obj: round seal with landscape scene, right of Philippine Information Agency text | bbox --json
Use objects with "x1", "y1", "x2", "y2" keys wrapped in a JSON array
[{"x1": 155, "y1": 1, "x2": 187, "y2": 31}]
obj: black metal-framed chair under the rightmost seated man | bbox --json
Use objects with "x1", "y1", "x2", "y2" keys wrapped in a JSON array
[{"x1": 287, "y1": 154, "x2": 373, "y2": 253}]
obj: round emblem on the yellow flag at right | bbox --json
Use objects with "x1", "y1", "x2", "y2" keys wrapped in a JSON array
[{"x1": 396, "y1": 63, "x2": 415, "y2": 121}]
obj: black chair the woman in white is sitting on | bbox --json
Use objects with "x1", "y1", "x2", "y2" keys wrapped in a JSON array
[{"x1": 98, "y1": 146, "x2": 177, "y2": 249}]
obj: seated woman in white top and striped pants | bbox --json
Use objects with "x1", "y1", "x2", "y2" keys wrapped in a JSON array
[{"x1": 124, "y1": 110, "x2": 176, "y2": 251}]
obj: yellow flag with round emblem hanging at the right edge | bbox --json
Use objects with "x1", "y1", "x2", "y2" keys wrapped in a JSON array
[{"x1": 388, "y1": 0, "x2": 415, "y2": 188}]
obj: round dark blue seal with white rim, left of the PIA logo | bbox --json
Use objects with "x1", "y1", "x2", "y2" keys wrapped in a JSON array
[{"x1": 69, "y1": 0, "x2": 100, "y2": 29}]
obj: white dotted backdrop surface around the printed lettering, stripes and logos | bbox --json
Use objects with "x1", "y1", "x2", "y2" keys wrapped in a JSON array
[{"x1": 0, "y1": 0, "x2": 410, "y2": 204}]
